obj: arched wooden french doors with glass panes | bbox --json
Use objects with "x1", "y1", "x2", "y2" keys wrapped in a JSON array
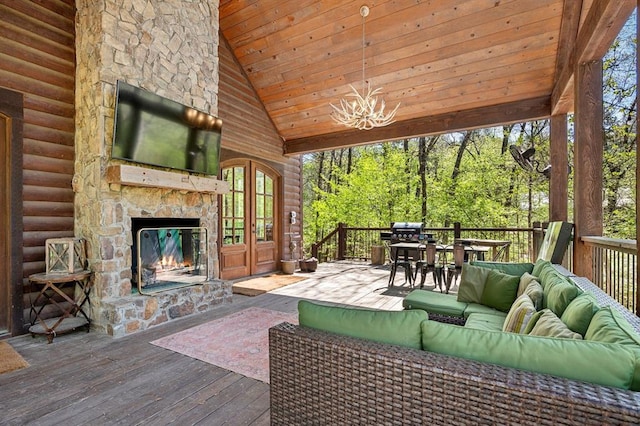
[{"x1": 220, "y1": 160, "x2": 280, "y2": 279}]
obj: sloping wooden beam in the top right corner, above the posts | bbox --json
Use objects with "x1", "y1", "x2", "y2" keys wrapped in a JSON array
[{"x1": 551, "y1": 0, "x2": 636, "y2": 115}]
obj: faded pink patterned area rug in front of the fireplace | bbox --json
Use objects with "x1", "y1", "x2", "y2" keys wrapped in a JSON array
[{"x1": 151, "y1": 307, "x2": 298, "y2": 383}]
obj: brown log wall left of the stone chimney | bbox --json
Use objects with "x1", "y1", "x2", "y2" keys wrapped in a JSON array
[{"x1": 0, "y1": 0, "x2": 75, "y2": 326}]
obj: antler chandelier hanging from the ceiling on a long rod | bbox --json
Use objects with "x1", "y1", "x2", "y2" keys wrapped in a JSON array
[{"x1": 330, "y1": 6, "x2": 400, "y2": 130}]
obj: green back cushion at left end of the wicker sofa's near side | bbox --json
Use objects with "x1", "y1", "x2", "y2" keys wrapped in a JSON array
[{"x1": 298, "y1": 300, "x2": 428, "y2": 349}]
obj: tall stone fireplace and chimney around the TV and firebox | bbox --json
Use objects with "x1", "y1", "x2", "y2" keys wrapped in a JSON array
[{"x1": 73, "y1": 0, "x2": 231, "y2": 336}]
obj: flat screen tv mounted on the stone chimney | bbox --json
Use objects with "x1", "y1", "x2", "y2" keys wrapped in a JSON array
[{"x1": 111, "y1": 81, "x2": 222, "y2": 176}]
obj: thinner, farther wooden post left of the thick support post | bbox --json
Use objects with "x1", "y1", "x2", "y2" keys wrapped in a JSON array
[{"x1": 549, "y1": 114, "x2": 569, "y2": 222}]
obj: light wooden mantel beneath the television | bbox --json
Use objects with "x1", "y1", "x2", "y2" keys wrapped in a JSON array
[{"x1": 107, "y1": 164, "x2": 229, "y2": 194}]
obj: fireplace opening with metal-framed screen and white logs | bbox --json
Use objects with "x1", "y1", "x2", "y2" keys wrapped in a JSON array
[{"x1": 131, "y1": 218, "x2": 208, "y2": 294}]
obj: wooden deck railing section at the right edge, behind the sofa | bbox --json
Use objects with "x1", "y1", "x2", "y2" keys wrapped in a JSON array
[{"x1": 581, "y1": 237, "x2": 640, "y2": 316}]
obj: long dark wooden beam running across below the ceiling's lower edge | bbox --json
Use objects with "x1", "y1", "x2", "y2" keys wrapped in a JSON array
[{"x1": 284, "y1": 96, "x2": 551, "y2": 155}]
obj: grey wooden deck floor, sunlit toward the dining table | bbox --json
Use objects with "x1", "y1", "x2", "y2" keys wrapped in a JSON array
[{"x1": 0, "y1": 263, "x2": 440, "y2": 425}]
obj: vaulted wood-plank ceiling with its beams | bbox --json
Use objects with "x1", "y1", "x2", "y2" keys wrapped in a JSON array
[{"x1": 220, "y1": 0, "x2": 636, "y2": 154}]
